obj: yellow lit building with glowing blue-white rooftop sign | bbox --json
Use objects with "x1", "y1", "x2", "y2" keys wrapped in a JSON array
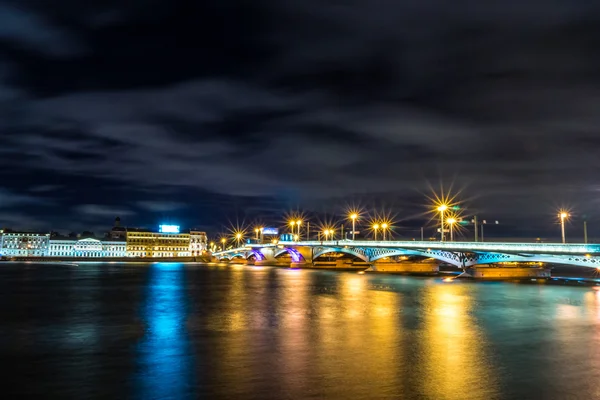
[{"x1": 127, "y1": 225, "x2": 190, "y2": 257}]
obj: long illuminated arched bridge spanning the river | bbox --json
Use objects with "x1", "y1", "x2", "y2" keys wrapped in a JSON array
[{"x1": 213, "y1": 240, "x2": 600, "y2": 270}]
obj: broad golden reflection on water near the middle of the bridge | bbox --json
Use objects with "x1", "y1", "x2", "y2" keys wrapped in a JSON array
[{"x1": 311, "y1": 274, "x2": 403, "y2": 398}]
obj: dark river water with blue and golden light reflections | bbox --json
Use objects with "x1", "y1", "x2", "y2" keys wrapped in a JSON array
[{"x1": 0, "y1": 263, "x2": 600, "y2": 400}]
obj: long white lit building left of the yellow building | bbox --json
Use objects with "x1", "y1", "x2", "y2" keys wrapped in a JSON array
[{"x1": 48, "y1": 238, "x2": 127, "y2": 258}]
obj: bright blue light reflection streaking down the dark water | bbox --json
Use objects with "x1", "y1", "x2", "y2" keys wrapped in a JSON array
[{"x1": 136, "y1": 263, "x2": 194, "y2": 399}]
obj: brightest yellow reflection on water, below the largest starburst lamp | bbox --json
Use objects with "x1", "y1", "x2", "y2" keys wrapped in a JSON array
[{"x1": 421, "y1": 284, "x2": 498, "y2": 399}]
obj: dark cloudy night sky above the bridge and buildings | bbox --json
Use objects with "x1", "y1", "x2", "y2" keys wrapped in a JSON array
[{"x1": 0, "y1": 0, "x2": 600, "y2": 236}]
